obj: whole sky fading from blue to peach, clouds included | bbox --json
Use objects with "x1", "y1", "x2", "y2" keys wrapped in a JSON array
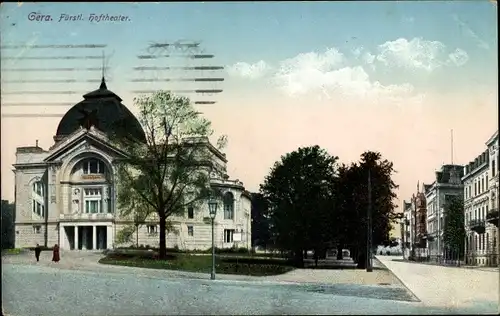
[{"x1": 0, "y1": 1, "x2": 498, "y2": 215}]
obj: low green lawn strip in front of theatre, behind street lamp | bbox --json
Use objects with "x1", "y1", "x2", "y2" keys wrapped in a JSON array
[{"x1": 99, "y1": 251, "x2": 294, "y2": 276}]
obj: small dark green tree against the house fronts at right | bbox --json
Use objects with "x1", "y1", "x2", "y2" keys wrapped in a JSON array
[{"x1": 443, "y1": 196, "x2": 466, "y2": 258}]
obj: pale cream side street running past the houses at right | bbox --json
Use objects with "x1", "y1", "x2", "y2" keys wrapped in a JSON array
[{"x1": 376, "y1": 256, "x2": 500, "y2": 308}]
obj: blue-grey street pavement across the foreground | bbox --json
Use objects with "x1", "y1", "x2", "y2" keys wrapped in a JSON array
[{"x1": 2, "y1": 253, "x2": 498, "y2": 316}]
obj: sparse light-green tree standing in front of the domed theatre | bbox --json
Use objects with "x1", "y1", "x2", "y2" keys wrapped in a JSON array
[{"x1": 112, "y1": 91, "x2": 225, "y2": 259}]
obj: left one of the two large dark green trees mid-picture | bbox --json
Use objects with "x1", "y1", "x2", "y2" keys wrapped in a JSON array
[{"x1": 260, "y1": 146, "x2": 338, "y2": 266}]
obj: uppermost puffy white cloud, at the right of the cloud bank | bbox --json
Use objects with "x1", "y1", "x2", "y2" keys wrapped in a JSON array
[{"x1": 377, "y1": 38, "x2": 445, "y2": 72}]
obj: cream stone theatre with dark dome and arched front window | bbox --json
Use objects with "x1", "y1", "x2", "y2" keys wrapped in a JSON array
[{"x1": 14, "y1": 78, "x2": 251, "y2": 250}]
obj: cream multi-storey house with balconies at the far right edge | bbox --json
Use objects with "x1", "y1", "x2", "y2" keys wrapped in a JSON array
[{"x1": 462, "y1": 131, "x2": 499, "y2": 266}]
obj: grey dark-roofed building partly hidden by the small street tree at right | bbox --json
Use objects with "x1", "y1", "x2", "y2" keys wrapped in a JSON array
[{"x1": 424, "y1": 165, "x2": 463, "y2": 257}]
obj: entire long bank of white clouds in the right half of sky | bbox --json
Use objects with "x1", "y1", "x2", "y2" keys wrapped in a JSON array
[{"x1": 228, "y1": 38, "x2": 469, "y2": 100}]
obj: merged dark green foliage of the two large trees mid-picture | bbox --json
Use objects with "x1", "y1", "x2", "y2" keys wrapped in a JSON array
[{"x1": 260, "y1": 146, "x2": 397, "y2": 270}]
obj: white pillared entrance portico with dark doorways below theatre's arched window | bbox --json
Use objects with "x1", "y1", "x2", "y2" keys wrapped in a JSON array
[{"x1": 59, "y1": 222, "x2": 113, "y2": 250}]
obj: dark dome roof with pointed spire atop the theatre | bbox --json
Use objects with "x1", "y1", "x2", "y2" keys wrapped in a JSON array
[{"x1": 55, "y1": 77, "x2": 146, "y2": 140}]
